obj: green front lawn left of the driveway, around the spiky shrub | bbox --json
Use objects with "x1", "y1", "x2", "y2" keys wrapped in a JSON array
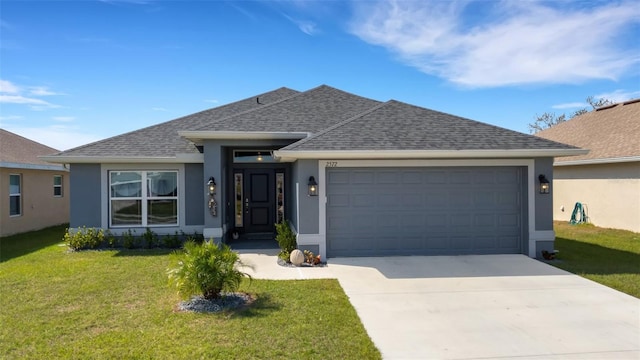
[{"x1": 0, "y1": 227, "x2": 380, "y2": 359}]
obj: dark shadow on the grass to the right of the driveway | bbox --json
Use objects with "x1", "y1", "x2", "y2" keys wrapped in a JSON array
[{"x1": 552, "y1": 237, "x2": 640, "y2": 275}]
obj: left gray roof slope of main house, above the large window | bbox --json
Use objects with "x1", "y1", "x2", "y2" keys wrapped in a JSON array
[{"x1": 60, "y1": 87, "x2": 298, "y2": 157}]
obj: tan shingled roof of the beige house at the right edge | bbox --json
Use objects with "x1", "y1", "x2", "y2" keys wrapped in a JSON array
[{"x1": 535, "y1": 99, "x2": 640, "y2": 165}]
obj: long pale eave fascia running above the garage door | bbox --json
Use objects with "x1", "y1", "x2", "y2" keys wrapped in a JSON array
[{"x1": 273, "y1": 149, "x2": 589, "y2": 162}]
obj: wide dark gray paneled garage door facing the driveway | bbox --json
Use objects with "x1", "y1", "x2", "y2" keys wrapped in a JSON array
[{"x1": 326, "y1": 167, "x2": 527, "y2": 257}]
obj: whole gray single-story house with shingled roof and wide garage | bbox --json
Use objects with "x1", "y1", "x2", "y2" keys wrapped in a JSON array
[{"x1": 47, "y1": 85, "x2": 585, "y2": 258}]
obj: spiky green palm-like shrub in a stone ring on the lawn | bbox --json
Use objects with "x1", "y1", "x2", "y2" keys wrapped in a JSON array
[{"x1": 167, "y1": 241, "x2": 251, "y2": 300}]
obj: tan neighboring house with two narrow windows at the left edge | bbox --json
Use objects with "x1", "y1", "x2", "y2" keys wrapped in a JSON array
[{"x1": 0, "y1": 129, "x2": 69, "y2": 236}]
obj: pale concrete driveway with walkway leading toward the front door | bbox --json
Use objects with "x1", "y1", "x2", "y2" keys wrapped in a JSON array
[{"x1": 241, "y1": 251, "x2": 640, "y2": 360}]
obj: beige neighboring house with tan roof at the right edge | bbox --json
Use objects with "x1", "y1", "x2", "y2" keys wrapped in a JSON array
[{"x1": 536, "y1": 99, "x2": 640, "y2": 232}]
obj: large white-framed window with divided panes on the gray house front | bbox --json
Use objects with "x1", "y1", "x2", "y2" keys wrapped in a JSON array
[{"x1": 109, "y1": 171, "x2": 178, "y2": 226}]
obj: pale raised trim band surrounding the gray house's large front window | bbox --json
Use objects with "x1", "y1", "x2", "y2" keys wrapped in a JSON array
[{"x1": 100, "y1": 164, "x2": 186, "y2": 230}]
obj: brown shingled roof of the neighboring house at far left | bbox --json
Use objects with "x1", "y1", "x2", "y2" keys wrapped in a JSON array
[{"x1": 0, "y1": 129, "x2": 58, "y2": 165}]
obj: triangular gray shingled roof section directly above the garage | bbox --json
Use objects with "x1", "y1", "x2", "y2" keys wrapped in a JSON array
[{"x1": 282, "y1": 100, "x2": 573, "y2": 151}]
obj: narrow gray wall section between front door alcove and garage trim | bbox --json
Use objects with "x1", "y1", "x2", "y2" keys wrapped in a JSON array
[{"x1": 293, "y1": 160, "x2": 320, "y2": 234}]
